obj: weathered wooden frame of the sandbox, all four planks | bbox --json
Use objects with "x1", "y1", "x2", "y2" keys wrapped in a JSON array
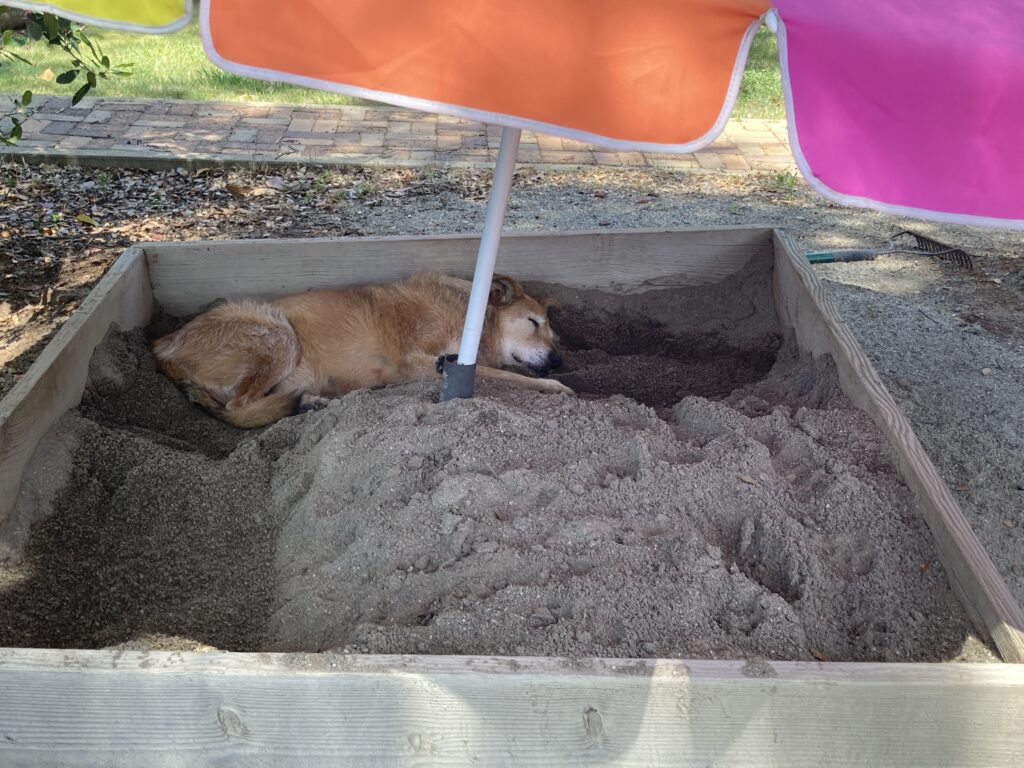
[{"x1": 0, "y1": 228, "x2": 1024, "y2": 768}]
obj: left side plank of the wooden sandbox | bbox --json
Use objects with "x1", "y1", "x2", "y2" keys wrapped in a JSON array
[{"x1": 0, "y1": 247, "x2": 153, "y2": 523}]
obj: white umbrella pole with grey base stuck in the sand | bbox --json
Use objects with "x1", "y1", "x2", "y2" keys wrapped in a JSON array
[{"x1": 441, "y1": 128, "x2": 521, "y2": 400}]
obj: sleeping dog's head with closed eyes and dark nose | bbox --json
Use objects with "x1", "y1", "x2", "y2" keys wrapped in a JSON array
[{"x1": 488, "y1": 274, "x2": 562, "y2": 376}]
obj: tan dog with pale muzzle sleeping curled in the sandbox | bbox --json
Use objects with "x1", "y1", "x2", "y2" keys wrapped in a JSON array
[{"x1": 153, "y1": 272, "x2": 572, "y2": 428}]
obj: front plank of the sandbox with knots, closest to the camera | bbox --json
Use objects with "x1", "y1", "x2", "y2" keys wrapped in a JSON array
[{"x1": 0, "y1": 650, "x2": 1024, "y2": 768}]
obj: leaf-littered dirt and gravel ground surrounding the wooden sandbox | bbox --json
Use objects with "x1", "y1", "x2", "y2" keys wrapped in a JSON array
[{"x1": 0, "y1": 160, "x2": 1024, "y2": 654}]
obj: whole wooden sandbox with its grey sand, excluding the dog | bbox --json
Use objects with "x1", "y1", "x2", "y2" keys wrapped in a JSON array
[{"x1": 0, "y1": 228, "x2": 1024, "y2": 765}]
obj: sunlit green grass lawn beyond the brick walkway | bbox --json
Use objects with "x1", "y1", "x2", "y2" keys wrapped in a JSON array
[{"x1": 0, "y1": 14, "x2": 783, "y2": 119}]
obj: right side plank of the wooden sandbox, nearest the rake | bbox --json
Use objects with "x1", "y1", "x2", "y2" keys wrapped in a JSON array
[{"x1": 774, "y1": 230, "x2": 1024, "y2": 663}]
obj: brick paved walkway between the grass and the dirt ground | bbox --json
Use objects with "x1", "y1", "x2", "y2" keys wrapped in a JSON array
[{"x1": 2, "y1": 96, "x2": 795, "y2": 171}]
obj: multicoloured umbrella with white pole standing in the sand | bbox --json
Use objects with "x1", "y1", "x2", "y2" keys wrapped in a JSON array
[{"x1": 8, "y1": 0, "x2": 1024, "y2": 398}]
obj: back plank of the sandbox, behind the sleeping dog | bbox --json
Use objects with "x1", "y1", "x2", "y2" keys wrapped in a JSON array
[{"x1": 142, "y1": 227, "x2": 771, "y2": 315}]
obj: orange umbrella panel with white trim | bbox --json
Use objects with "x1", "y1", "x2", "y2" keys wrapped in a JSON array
[{"x1": 202, "y1": 0, "x2": 770, "y2": 152}]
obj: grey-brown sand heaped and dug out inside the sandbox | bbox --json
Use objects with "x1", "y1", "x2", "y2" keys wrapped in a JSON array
[{"x1": 0, "y1": 264, "x2": 991, "y2": 662}]
